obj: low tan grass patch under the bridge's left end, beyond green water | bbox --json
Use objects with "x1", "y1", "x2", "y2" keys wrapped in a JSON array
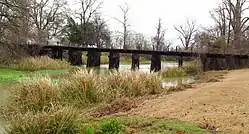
[{"x1": 10, "y1": 56, "x2": 70, "y2": 71}]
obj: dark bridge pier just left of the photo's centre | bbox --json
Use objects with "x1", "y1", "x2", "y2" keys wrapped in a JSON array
[{"x1": 109, "y1": 52, "x2": 120, "y2": 70}]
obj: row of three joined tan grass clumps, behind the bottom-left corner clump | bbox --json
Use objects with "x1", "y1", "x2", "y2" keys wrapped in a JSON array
[{"x1": 2, "y1": 69, "x2": 162, "y2": 116}]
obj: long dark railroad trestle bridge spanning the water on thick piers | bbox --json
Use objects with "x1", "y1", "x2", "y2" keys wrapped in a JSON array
[{"x1": 28, "y1": 45, "x2": 249, "y2": 71}]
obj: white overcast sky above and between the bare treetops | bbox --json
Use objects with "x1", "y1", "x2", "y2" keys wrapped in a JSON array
[{"x1": 69, "y1": 0, "x2": 220, "y2": 45}]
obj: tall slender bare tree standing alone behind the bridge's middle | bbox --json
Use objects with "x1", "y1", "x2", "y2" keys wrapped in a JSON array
[{"x1": 115, "y1": 3, "x2": 129, "y2": 49}]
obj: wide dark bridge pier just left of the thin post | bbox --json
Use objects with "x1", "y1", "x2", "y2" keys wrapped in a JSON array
[{"x1": 150, "y1": 53, "x2": 161, "y2": 72}]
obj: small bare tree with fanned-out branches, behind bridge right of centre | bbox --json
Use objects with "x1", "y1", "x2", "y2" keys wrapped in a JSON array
[{"x1": 175, "y1": 20, "x2": 198, "y2": 50}]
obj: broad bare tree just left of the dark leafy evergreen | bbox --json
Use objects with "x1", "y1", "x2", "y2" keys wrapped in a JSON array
[{"x1": 30, "y1": 0, "x2": 66, "y2": 43}]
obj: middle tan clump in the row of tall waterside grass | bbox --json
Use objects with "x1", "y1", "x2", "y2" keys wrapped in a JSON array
[{"x1": 61, "y1": 69, "x2": 103, "y2": 106}]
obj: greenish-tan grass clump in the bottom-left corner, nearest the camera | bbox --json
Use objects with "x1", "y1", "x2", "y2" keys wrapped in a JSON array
[{"x1": 5, "y1": 108, "x2": 80, "y2": 134}]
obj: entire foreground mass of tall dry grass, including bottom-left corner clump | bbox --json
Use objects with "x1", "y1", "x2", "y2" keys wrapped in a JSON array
[{"x1": 1, "y1": 69, "x2": 162, "y2": 134}]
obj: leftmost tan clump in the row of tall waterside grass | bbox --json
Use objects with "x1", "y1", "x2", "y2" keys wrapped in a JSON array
[{"x1": 5, "y1": 77, "x2": 59, "y2": 114}]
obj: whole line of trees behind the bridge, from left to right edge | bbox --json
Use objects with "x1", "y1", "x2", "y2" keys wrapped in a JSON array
[{"x1": 0, "y1": 0, "x2": 249, "y2": 62}]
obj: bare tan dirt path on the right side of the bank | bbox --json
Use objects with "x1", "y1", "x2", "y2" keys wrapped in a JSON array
[{"x1": 120, "y1": 69, "x2": 249, "y2": 134}]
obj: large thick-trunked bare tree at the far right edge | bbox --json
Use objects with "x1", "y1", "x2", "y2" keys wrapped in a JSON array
[{"x1": 211, "y1": 0, "x2": 249, "y2": 52}]
